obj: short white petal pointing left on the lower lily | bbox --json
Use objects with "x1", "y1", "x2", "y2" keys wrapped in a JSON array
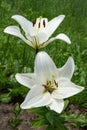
[{"x1": 15, "y1": 73, "x2": 36, "y2": 88}]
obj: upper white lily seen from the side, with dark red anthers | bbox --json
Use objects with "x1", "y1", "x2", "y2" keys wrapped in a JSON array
[{"x1": 4, "y1": 15, "x2": 71, "y2": 50}]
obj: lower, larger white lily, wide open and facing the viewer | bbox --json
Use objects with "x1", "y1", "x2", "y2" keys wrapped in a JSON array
[{"x1": 16, "y1": 52, "x2": 84, "y2": 113}]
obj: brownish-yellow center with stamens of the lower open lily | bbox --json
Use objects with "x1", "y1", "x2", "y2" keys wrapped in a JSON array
[{"x1": 43, "y1": 75, "x2": 58, "y2": 93}]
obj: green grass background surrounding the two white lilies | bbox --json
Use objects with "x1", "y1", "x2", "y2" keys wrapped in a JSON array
[{"x1": 0, "y1": 0, "x2": 87, "y2": 127}]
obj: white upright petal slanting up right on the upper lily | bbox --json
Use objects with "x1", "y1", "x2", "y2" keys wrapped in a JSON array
[{"x1": 46, "y1": 15, "x2": 65, "y2": 37}]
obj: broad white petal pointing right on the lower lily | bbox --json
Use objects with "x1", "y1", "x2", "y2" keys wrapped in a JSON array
[{"x1": 52, "y1": 78, "x2": 84, "y2": 99}]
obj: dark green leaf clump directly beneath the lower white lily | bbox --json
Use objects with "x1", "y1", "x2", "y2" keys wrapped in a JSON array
[{"x1": 29, "y1": 107, "x2": 68, "y2": 130}]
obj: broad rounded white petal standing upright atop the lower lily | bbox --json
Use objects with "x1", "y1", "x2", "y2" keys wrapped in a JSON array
[{"x1": 35, "y1": 52, "x2": 57, "y2": 83}]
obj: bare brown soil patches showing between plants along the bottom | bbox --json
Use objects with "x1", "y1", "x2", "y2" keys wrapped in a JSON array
[{"x1": 0, "y1": 103, "x2": 87, "y2": 130}]
